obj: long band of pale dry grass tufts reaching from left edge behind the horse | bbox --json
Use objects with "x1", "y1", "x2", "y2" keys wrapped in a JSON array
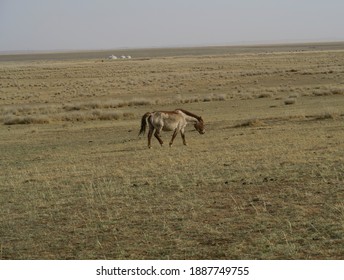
[{"x1": 0, "y1": 94, "x2": 226, "y2": 125}]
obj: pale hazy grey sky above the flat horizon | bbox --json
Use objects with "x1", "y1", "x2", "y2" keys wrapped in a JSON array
[{"x1": 0, "y1": 0, "x2": 344, "y2": 51}]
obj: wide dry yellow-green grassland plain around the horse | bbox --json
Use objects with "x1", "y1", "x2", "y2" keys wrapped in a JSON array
[{"x1": 0, "y1": 43, "x2": 344, "y2": 259}]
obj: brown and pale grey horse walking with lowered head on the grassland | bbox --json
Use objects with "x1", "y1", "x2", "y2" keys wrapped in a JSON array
[{"x1": 139, "y1": 109, "x2": 205, "y2": 148}]
